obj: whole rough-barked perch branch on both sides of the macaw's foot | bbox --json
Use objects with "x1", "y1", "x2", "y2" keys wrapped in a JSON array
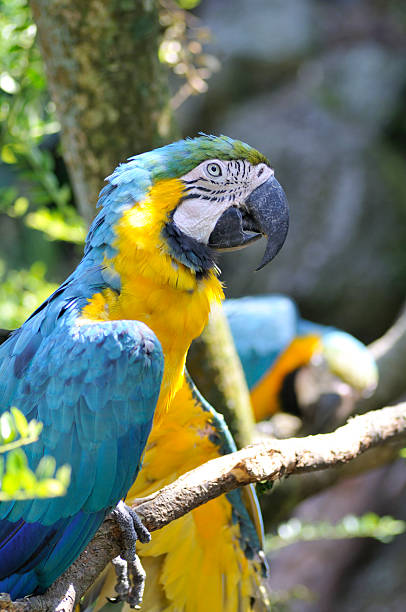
[{"x1": 0, "y1": 403, "x2": 406, "y2": 612}]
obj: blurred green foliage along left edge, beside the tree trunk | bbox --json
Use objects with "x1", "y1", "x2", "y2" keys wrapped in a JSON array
[{"x1": 0, "y1": 0, "x2": 85, "y2": 328}]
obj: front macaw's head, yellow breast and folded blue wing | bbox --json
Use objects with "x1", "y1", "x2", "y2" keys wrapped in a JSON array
[{"x1": 0, "y1": 135, "x2": 288, "y2": 598}]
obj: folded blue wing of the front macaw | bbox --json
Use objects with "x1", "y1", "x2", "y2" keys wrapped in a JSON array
[{"x1": 0, "y1": 298, "x2": 163, "y2": 597}]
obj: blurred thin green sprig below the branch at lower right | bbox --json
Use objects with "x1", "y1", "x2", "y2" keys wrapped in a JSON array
[{"x1": 265, "y1": 512, "x2": 406, "y2": 553}]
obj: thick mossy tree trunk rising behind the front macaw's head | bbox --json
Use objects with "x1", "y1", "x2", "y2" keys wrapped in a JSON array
[{"x1": 31, "y1": 0, "x2": 179, "y2": 222}]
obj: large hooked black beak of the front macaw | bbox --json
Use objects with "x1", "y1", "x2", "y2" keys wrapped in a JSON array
[{"x1": 209, "y1": 176, "x2": 289, "y2": 270}]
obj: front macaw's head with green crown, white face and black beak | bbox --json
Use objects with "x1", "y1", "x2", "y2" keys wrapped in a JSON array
[{"x1": 91, "y1": 135, "x2": 289, "y2": 276}]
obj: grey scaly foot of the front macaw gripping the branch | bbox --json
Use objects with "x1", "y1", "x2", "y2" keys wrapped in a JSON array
[{"x1": 108, "y1": 501, "x2": 151, "y2": 609}]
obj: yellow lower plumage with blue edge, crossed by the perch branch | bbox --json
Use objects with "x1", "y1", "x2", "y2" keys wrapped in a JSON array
[{"x1": 81, "y1": 380, "x2": 268, "y2": 612}]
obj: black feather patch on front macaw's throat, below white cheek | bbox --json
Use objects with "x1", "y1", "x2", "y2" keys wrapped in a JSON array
[{"x1": 162, "y1": 218, "x2": 216, "y2": 280}]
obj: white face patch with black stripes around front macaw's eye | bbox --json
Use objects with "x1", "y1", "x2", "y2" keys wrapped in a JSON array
[{"x1": 173, "y1": 159, "x2": 274, "y2": 244}]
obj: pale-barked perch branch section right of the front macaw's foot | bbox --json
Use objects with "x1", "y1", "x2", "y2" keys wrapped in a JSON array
[{"x1": 136, "y1": 403, "x2": 406, "y2": 531}]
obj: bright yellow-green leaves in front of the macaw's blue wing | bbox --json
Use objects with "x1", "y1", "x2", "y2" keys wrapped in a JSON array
[{"x1": 0, "y1": 407, "x2": 70, "y2": 501}]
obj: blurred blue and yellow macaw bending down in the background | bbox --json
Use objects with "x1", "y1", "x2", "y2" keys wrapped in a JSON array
[{"x1": 224, "y1": 295, "x2": 378, "y2": 421}]
